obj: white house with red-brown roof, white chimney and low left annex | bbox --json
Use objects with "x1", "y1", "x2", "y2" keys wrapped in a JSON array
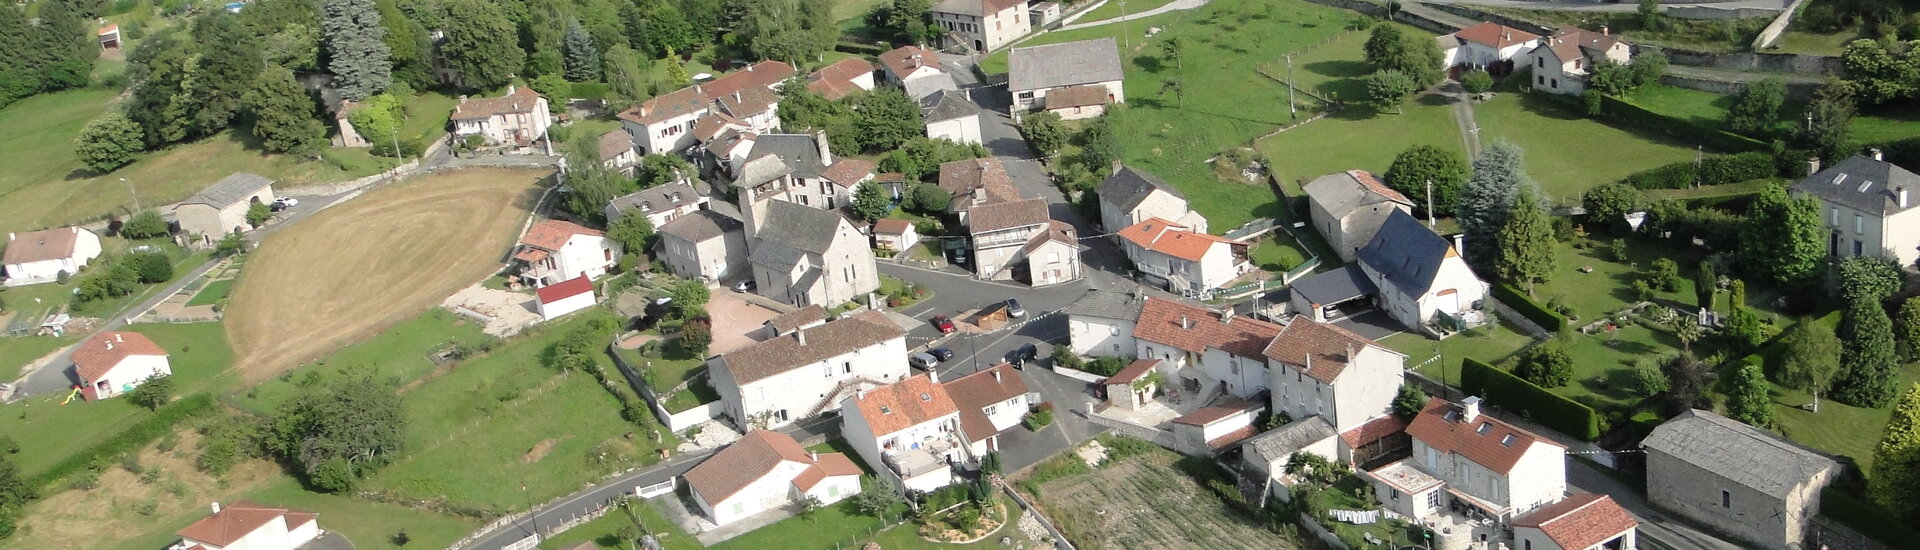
[{"x1": 1367, "y1": 398, "x2": 1567, "y2": 523}]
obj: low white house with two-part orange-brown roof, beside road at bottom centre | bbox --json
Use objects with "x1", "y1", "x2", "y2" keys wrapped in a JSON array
[{"x1": 682, "y1": 429, "x2": 860, "y2": 525}]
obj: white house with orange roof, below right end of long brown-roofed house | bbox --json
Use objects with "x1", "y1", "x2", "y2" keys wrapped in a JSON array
[{"x1": 841, "y1": 371, "x2": 970, "y2": 490}]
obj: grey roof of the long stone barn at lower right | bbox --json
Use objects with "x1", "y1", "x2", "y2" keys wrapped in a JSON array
[{"x1": 1640, "y1": 410, "x2": 1839, "y2": 498}]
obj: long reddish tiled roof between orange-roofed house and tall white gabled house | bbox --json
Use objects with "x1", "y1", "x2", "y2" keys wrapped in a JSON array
[{"x1": 1133, "y1": 298, "x2": 1281, "y2": 360}]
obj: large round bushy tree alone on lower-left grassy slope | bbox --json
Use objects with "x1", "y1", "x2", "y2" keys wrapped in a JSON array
[{"x1": 267, "y1": 375, "x2": 407, "y2": 492}]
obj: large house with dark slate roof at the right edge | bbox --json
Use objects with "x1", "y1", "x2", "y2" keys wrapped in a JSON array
[{"x1": 1789, "y1": 148, "x2": 1920, "y2": 265}]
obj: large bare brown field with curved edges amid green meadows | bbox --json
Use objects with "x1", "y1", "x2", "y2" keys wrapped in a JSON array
[{"x1": 227, "y1": 169, "x2": 549, "y2": 385}]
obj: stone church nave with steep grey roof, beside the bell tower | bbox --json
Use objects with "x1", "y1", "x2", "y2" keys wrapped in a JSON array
[{"x1": 747, "y1": 200, "x2": 879, "y2": 307}]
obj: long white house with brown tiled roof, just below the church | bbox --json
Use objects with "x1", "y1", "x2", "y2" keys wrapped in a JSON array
[{"x1": 707, "y1": 310, "x2": 908, "y2": 429}]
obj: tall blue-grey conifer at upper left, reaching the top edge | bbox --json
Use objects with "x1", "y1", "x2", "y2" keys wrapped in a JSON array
[{"x1": 321, "y1": 0, "x2": 394, "y2": 102}]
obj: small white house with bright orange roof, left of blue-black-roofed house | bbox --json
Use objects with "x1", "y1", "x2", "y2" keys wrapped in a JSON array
[{"x1": 1116, "y1": 217, "x2": 1254, "y2": 296}]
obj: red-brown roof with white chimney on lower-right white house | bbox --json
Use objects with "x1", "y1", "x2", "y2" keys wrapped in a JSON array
[{"x1": 1407, "y1": 396, "x2": 1567, "y2": 475}]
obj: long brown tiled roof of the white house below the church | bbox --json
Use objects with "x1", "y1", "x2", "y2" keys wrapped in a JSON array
[{"x1": 718, "y1": 310, "x2": 906, "y2": 385}]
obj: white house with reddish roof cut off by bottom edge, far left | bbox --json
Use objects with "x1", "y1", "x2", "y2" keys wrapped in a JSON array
[{"x1": 177, "y1": 500, "x2": 324, "y2": 550}]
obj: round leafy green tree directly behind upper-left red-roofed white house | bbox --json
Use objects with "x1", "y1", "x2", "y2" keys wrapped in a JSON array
[{"x1": 440, "y1": 0, "x2": 526, "y2": 88}]
